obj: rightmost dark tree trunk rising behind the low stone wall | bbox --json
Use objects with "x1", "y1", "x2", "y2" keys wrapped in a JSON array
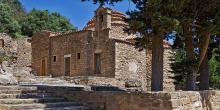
[{"x1": 199, "y1": 54, "x2": 209, "y2": 90}]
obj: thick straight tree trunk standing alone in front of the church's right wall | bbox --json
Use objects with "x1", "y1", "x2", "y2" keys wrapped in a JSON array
[{"x1": 151, "y1": 36, "x2": 163, "y2": 91}]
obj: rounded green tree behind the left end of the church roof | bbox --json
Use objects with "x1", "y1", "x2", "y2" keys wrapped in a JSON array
[{"x1": 21, "y1": 9, "x2": 76, "y2": 36}]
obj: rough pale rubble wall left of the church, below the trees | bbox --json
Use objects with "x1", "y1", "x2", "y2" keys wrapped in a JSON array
[{"x1": 0, "y1": 33, "x2": 32, "y2": 67}]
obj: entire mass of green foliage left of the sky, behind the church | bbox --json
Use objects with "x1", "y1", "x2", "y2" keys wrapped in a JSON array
[{"x1": 0, "y1": 0, "x2": 75, "y2": 38}]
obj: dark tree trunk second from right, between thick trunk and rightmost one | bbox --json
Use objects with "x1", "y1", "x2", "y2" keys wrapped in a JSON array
[{"x1": 184, "y1": 26, "x2": 197, "y2": 90}]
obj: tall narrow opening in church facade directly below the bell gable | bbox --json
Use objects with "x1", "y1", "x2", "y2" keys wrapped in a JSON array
[{"x1": 94, "y1": 54, "x2": 101, "y2": 74}]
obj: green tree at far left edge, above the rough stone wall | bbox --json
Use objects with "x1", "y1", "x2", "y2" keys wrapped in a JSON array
[{"x1": 0, "y1": 3, "x2": 21, "y2": 38}]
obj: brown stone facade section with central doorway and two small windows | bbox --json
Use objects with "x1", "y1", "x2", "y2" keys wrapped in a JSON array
[{"x1": 50, "y1": 31, "x2": 92, "y2": 76}]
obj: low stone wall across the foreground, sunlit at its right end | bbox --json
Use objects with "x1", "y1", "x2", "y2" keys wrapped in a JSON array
[{"x1": 49, "y1": 86, "x2": 220, "y2": 110}]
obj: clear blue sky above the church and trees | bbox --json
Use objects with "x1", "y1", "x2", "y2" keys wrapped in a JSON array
[{"x1": 20, "y1": 0, "x2": 134, "y2": 29}]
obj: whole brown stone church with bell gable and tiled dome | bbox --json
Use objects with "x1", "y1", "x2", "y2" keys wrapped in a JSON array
[{"x1": 32, "y1": 7, "x2": 173, "y2": 90}]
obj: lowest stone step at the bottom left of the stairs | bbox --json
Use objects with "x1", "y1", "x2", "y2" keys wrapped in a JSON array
[{"x1": 0, "y1": 102, "x2": 84, "y2": 110}]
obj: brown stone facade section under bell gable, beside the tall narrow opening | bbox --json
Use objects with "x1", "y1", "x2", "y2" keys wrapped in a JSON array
[{"x1": 92, "y1": 29, "x2": 115, "y2": 77}]
